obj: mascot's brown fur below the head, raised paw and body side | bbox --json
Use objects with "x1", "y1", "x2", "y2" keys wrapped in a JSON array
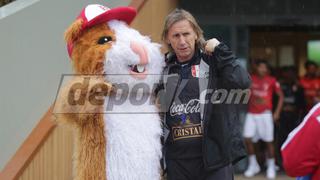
[{"x1": 55, "y1": 76, "x2": 112, "y2": 180}]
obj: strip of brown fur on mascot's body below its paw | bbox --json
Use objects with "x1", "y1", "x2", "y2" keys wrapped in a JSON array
[{"x1": 74, "y1": 114, "x2": 106, "y2": 180}]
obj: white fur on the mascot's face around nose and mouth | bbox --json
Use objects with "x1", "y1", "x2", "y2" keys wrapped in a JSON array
[{"x1": 105, "y1": 20, "x2": 164, "y2": 88}]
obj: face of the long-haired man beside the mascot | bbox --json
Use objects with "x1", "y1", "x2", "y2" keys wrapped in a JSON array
[{"x1": 166, "y1": 20, "x2": 198, "y2": 62}]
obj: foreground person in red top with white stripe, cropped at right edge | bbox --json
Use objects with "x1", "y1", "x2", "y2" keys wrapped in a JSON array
[{"x1": 281, "y1": 103, "x2": 320, "y2": 180}]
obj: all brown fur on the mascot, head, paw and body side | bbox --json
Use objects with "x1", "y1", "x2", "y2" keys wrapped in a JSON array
[{"x1": 55, "y1": 20, "x2": 115, "y2": 180}]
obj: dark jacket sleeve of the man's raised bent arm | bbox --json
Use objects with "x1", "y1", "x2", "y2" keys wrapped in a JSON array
[{"x1": 211, "y1": 42, "x2": 251, "y2": 89}]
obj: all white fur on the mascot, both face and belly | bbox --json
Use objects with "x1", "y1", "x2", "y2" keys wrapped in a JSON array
[{"x1": 104, "y1": 21, "x2": 164, "y2": 180}]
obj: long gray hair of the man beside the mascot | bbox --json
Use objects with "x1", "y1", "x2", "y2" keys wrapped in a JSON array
[{"x1": 162, "y1": 9, "x2": 205, "y2": 53}]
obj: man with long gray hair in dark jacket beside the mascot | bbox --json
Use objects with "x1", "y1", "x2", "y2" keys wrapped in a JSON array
[{"x1": 160, "y1": 9, "x2": 251, "y2": 180}]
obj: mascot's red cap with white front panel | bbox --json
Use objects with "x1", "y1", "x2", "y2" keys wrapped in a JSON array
[{"x1": 67, "y1": 4, "x2": 137, "y2": 57}]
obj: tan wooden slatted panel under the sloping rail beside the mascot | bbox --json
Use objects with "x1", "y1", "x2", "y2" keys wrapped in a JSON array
[{"x1": 18, "y1": 126, "x2": 73, "y2": 180}]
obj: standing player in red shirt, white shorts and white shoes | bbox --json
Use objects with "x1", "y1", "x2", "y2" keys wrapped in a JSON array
[{"x1": 243, "y1": 60, "x2": 283, "y2": 179}]
